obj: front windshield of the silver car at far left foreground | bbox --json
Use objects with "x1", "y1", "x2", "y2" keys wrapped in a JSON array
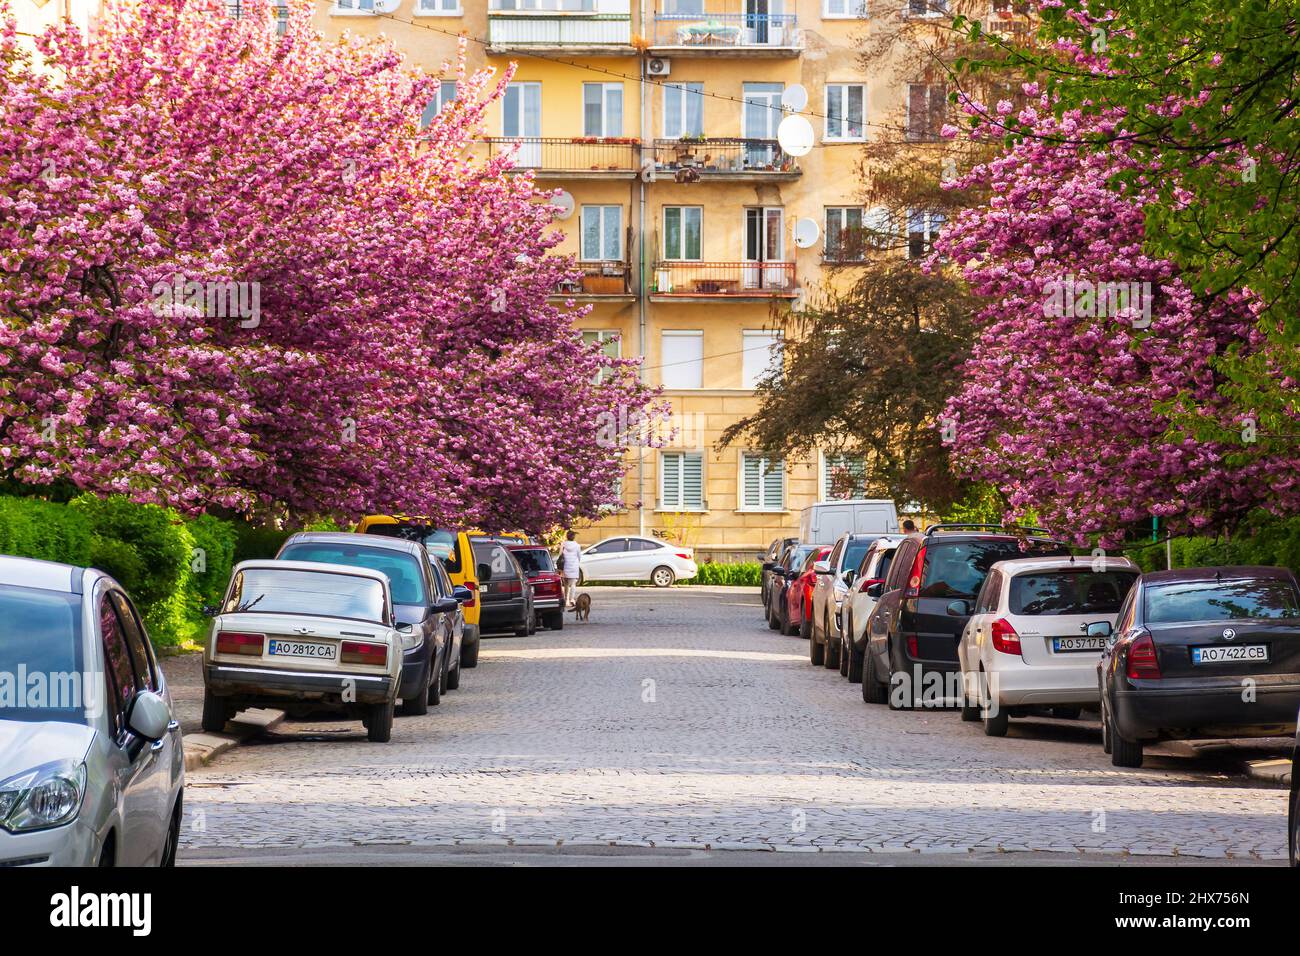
[{"x1": 0, "y1": 587, "x2": 86, "y2": 723}]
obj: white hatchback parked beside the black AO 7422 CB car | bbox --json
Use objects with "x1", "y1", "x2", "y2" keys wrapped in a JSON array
[{"x1": 954, "y1": 558, "x2": 1140, "y2": 737}]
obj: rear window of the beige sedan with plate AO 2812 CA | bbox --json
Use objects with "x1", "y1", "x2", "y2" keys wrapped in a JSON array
[{"x1": 221, "y1": 567, "x2": 387, "y2": 624}]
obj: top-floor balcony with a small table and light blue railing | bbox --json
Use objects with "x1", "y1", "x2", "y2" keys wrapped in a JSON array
[{"x1": 650, "y1": 10, "x2": 803, "y2": 57}]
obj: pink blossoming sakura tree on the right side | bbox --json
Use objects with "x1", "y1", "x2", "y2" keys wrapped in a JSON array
[{"x1": 936, "y1": 93, "x2": 1300, "y2": 545}]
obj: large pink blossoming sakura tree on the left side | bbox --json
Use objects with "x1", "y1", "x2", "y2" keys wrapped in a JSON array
[{"x1": 0, "y1": 0, "x2": 653, "y2": 529}]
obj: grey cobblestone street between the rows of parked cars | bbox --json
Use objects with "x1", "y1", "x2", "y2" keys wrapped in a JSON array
[{"x1": 182, "y1": 588, "x2": 1286, "y2": 862}]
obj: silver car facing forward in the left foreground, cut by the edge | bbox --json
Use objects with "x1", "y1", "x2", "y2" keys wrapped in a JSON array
[{"x1": 0, "y1": 557, "x2": 185, "y2": 866}]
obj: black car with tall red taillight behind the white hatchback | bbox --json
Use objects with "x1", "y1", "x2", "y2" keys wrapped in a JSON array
[{"x1": 862, "y1": 524, "x2": 1070, "y2": 709}]
